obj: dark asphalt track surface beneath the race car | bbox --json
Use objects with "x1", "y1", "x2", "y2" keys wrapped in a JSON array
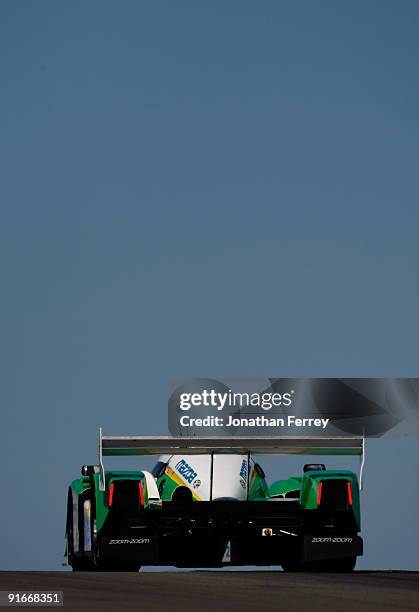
[{"x1": 0, "y1": 571, "x2": 419, "y2": 612}]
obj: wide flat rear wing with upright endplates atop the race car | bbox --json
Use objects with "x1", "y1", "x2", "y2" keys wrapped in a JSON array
[{"x1": 99, "y1": 428, "x2": 365, "y2": 488}]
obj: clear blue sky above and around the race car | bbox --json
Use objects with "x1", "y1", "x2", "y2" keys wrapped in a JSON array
[{"x1": 0, "y1": 0, "x2": 419, "y2": 569}]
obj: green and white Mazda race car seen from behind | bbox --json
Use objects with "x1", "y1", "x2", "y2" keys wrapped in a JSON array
[{"x1": 66, "y1": 430, "x2": 364, "y2": 572}]
